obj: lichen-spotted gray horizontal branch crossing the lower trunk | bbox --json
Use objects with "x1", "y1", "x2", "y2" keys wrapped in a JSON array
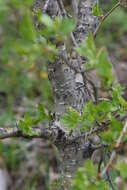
[{"x1": 0, "y1": 115, "x2": 127, "y2": 140}]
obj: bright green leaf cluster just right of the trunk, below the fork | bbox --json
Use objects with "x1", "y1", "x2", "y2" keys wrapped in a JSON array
[{"x1": 76, "y1": 33, "x2": 114, "y2": 89}]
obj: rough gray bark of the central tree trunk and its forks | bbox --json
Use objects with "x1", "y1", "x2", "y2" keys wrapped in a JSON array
[{"x1": 35, "y1": 0, "x2": 98, "y2": 187}]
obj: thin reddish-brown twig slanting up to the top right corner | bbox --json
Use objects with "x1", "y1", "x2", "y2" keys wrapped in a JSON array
[{"x1": 93, "y1": 1, "x2": 121, "y2": 37}]
